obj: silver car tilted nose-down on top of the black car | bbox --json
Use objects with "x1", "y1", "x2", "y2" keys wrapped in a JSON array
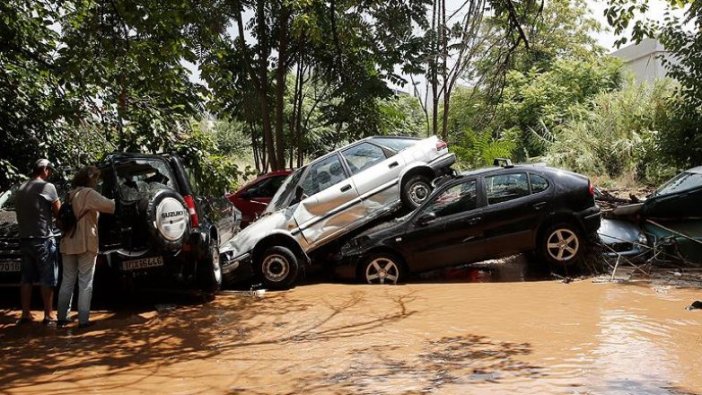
[{"x1": 222, "y1": 136, "x2": 456, "y2": 289}]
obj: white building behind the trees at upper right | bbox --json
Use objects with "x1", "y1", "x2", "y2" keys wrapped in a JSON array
[{"x1": 612, "y1": 38, "x2": 673, "y2": 83}]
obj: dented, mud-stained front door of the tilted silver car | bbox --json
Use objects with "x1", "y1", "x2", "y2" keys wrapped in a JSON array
[{"x1": 293, "y1": 153, "x2": 366, "y2": 250}]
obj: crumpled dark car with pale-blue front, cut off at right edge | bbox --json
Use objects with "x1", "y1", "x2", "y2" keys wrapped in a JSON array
[{"x1": 598, "y1": 166, "x2": 702, "y2": 265}]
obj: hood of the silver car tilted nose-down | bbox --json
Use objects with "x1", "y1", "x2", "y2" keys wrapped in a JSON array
[{"x1": 220, "y1": 210, "x2": 294, "y2": 259}]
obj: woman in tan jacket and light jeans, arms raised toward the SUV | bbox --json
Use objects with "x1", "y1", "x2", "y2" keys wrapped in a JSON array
[{"x1": 58, "y1": 166, "x2": 115, "y2": 328}]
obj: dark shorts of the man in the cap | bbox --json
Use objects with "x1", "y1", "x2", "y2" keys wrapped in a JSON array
[{"x1": 20, "y1": 237, "x2": 58, "y2": 287}]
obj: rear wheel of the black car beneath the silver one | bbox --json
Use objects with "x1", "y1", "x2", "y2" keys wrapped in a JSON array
[{"x1": 539, "y1": 222, "x2": 585, "y2": 271}]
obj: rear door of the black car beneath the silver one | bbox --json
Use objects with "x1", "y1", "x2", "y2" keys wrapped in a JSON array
[{"x1": 483, "y1": 171, "x2": 553, "y2": 257}]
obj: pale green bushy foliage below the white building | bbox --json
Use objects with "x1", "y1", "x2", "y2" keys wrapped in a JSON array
[{"x1": 546, "y1": 81, "x2": 675, "y2": 184}]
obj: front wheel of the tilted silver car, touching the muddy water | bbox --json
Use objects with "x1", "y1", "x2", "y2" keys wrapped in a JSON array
[{"x1": 255, "y1": 246, "x2": 299, "y2": 289}]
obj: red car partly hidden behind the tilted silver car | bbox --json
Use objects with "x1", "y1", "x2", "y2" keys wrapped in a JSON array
[{"x1": 227, "y1": 170, "x2": 292, "y2": 229}]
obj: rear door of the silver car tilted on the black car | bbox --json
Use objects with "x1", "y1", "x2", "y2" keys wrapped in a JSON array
[{"x1": 341, "y1": 141, "x2": 405, "y2": 216}]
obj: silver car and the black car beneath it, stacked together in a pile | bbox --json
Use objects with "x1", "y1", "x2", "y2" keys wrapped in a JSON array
[{"x1": 221, "y1": 137, "x2": 600, "y2": 289}]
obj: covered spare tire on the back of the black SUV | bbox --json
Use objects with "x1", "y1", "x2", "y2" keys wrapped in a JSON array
[{"x1": 145, "y1": 189, "x2": 190, "y2": 252}]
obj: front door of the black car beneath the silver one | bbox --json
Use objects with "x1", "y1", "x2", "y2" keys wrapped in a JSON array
[{"x1": 401, "y1": 178, "x2": 485, "y2": 271}]
